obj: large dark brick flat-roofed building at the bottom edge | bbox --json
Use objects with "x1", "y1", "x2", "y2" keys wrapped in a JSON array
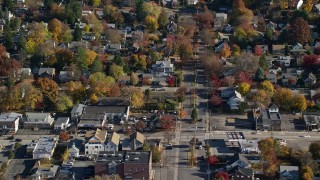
[{"x1": 94, "y1": 151, "x2": 153, "y2": 179}]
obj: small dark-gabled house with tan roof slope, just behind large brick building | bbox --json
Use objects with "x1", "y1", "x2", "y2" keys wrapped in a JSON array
[{"x1": 122, "y1": 132, "x2": 145, "y2": 151}]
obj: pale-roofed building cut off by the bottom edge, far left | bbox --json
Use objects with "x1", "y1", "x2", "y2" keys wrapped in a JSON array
[{"x1": 31, "y1": 165, "x2": 59, "y2": 180}]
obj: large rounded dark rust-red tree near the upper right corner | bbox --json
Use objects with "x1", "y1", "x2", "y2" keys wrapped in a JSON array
[{"x1": 289, "y1": 17, "x2": 311, "y2": 44}]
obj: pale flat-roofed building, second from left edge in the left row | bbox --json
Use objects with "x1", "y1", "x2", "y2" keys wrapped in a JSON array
[{"x1": 23, "y1": 112, "x2": 54, "y2": 129}]
